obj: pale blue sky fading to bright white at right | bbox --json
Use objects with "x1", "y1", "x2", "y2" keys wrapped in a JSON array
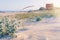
[{"x1": 0, "y1": 0, "x2": 60, "y2": 11}]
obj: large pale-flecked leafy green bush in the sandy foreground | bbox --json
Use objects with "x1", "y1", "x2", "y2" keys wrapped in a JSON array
[{"x1": 0, "y1": 16, "x2": 17, "y2": 38}]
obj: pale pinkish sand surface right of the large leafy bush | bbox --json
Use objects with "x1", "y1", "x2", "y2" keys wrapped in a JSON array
[{"x1": 13, "y1": 18, "x2": 60, "y2": 40}]
